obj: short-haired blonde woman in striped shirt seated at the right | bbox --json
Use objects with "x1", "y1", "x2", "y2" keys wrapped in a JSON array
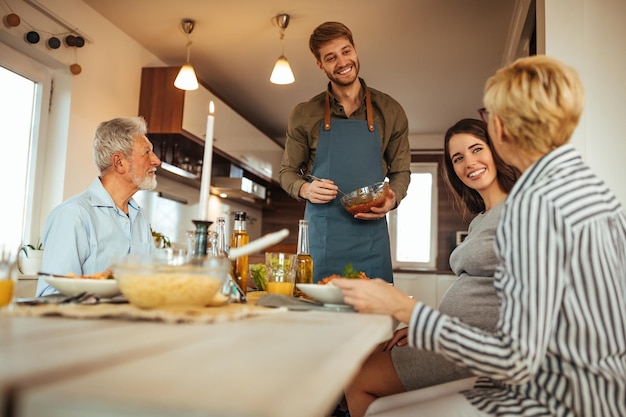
[{"x1": 334, "y1": 56, "x2": 626, "y2": 417}]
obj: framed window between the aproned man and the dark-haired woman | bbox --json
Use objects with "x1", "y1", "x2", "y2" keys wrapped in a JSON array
[{"x1": 389, "y1": 162, "x2": 438, "y2": 270}]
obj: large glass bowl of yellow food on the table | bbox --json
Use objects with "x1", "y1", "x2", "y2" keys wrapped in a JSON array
[{"x1": 112, "y1": 251, "x2": 230, "y2": 308}]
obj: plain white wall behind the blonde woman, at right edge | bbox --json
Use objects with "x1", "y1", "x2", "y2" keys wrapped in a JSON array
[{"x1": 537, "y1": 0, "x2": 626, "y2": 205}]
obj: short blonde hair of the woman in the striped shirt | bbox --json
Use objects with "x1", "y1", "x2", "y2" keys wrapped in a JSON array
[{"x1": 483, "y1": 55, "x2": 585, "y2": 153}]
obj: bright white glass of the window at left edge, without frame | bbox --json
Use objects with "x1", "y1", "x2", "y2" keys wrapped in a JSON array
[{"x1": 0, "y1": 66, "x2": 36, "y2": 247}]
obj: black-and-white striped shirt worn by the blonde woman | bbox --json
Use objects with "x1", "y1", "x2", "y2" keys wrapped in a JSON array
[{"x1": 409, "y1": 145, "x2": 626, "y2": 417}]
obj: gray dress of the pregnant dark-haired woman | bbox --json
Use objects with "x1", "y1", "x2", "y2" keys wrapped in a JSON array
[{"x1": 391, "y1": 203, "x2": 503, "y2": 391}]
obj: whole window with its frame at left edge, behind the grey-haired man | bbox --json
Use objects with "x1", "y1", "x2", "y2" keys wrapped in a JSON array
[{"x1": 0, "y1": 43, "x2": 52, "y2": 247}]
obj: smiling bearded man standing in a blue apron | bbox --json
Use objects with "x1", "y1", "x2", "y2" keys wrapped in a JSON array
[{"x1": 280, "y1": 22, "x2": 411, "y2": 282}]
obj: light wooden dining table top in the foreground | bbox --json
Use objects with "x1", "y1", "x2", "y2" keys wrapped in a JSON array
[{"x1": 0, "y1": 292, "x2": 394, "y2": 417}]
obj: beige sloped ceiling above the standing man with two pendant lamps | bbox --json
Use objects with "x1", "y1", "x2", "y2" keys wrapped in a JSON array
[{"x1": 83, "y1": 0, "x2": 528, "y2": 144}]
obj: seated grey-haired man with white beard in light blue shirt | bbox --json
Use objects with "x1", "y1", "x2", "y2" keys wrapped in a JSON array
[{"x1": 37, "y1": 117, "x2": 161, "y2": 296}]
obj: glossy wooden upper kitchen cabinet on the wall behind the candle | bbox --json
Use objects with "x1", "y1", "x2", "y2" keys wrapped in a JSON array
[{"x1": 139, "y1": 67, "x2": 283, "y2": 184}]
